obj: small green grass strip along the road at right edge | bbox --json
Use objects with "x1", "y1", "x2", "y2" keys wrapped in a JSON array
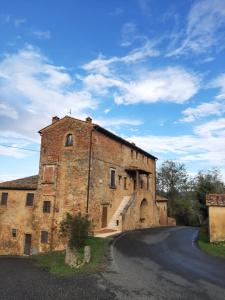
[{"x1": 197, "y1": 229, "x2": 225, "y2": 258}]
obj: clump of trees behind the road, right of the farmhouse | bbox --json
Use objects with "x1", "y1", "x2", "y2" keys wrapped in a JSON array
[{"x1": 157, "y1": 160, "x2": 225, "y2": 226}]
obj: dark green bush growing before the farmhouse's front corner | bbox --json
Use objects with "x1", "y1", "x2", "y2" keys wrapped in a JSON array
[{"x1": 60, "y1": 213, "x2": 92, "y2": 249}]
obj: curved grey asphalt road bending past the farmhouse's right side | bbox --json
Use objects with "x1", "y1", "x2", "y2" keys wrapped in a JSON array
[{"x1": 103, "y1": 227, "x2": 225, "y2": 300}]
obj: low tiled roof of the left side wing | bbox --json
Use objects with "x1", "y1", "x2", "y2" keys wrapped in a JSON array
[{"x1": 0, "y1": 175, "x2": 38, "y2": 190}]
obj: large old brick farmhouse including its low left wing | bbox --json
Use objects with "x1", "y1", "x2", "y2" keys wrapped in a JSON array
[{"x1": 0, "y1": 116, "x2": 167, "y2": 254}]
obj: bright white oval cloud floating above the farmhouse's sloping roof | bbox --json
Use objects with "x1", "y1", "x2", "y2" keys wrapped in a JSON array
[{"x1": 115, "y1": 67, "x2": 200, "y2": 104}]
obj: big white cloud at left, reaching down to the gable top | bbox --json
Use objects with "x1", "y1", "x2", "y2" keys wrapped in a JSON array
[{"x1": 0, "y1": 46, "x2": 97, "y2": 140}]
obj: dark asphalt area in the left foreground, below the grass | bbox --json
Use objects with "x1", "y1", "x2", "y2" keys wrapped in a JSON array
[{"x1": 0, "y1": 257, "x2": 116, "y2": 300}]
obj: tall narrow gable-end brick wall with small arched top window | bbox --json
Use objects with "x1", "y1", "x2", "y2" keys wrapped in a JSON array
[{"x1": 33, "y1": 118, "x2": 92, "y2": 252}]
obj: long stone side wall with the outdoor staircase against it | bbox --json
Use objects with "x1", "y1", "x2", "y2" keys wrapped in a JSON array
[{"x1": 89, "y1": 132, "x2": 157, "y2": 230}]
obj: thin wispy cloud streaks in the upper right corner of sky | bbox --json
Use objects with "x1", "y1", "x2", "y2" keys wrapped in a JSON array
[{"x1": 168, "y1": 0, "x2": 225, "y2": 56}]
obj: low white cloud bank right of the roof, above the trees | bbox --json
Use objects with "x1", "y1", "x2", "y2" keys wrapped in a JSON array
[{"x1": 129, "y1": 120, "x2": 225, "y2": 168}]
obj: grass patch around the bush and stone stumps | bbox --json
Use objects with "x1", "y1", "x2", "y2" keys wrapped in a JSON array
[{"x1": 32, "y1": 237, "x2": 109, "y2": 276}]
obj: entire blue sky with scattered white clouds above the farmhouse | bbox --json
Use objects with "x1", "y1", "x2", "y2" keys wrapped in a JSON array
[{"x1": 0, "y1": 0, "x2": 225, "y2": 181}]
